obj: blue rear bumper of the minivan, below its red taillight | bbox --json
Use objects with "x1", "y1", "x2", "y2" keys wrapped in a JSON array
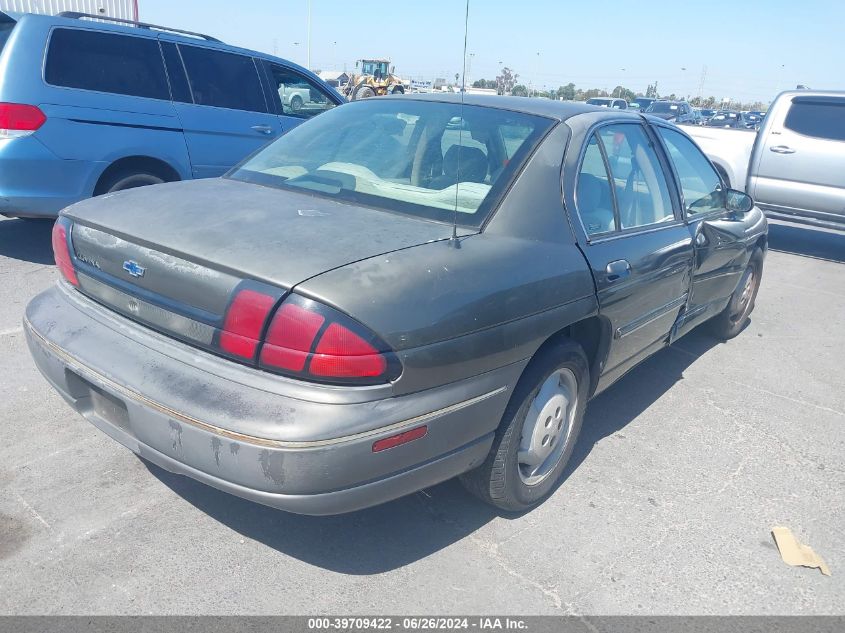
[{"x1": 0, "y1": 136, "x2": 105, "y2": 217}]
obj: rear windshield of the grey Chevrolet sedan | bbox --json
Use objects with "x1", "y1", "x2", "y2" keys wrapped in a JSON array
[{"x1": 229, "y1": 99, "x2": 554, "y2": 227}]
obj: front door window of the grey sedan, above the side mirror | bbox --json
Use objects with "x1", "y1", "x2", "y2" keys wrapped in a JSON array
[{"x1": 657, "y1": 127, "x2": 725, "y2": 215}]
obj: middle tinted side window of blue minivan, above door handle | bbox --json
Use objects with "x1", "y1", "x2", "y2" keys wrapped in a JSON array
[{"x1": 179, "y1": 44, "x2": 267, "y2": 112}]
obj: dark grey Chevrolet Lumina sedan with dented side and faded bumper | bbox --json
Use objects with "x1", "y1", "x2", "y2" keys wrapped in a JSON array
[{"x1": 24, "y1": 95, "x2": 767, "y2": 514}]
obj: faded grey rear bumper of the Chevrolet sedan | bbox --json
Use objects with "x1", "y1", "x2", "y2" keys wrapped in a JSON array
[{"x1": 25, "y1": 284, "x2": 522, "y2": 514}]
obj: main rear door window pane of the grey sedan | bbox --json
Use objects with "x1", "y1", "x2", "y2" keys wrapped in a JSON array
[{"x1": 598, "y1": 123, "x2": 675, "y2": 230}]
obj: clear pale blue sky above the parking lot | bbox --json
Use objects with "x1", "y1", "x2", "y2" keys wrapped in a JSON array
[{"x1": 139, "y1": 0, "x2": 845, "y2": 101}]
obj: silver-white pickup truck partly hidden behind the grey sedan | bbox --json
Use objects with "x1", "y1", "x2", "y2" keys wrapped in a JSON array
[{"x1": 683, "y1": 90, "x2": 845, "y2": 229}]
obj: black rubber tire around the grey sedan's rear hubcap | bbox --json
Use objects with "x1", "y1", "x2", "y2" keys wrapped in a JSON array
[{"x1": 460, "y1": 339, "x2": 590, "y2": 512}]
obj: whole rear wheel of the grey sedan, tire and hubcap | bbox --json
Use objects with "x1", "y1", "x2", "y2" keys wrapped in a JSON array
[{"x1": 461, "y1": 339, "x2": 590, "y2": 512}]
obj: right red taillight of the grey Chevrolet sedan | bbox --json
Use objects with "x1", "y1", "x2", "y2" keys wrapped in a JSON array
[{"x1": 259, "y1": 295, "x2": 399, "y2": 385}]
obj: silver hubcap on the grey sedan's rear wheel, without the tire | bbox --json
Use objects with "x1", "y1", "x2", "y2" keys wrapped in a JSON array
[{"x1": 517, "y1": 369, "x2": 578, "y2": 486}]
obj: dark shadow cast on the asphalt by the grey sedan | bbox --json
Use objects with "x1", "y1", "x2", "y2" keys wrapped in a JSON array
[{"x1": 143, "y1": 332, "x2": 718, "y2": 575}]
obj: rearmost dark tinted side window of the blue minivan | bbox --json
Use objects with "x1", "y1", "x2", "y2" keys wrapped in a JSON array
[{"x1": 45, "y1": 29, "x2": 170, "y2": 99}]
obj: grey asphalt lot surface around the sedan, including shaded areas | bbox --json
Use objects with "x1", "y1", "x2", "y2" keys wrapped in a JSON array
[{"x1": 0, "y1": 220, "x2": 845, "y2": 615}]
